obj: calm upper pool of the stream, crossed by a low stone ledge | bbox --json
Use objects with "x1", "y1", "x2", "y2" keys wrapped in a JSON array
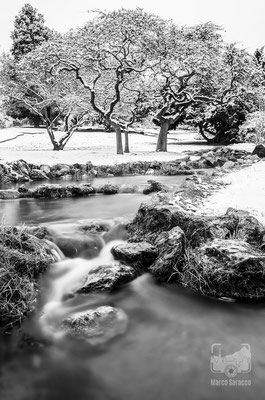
[{"x1": 0, "y1": 176, "x2": 185, "y2": 225}]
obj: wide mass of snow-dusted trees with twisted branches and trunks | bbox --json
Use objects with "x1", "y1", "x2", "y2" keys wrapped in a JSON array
[{"x1": 2, "y1": 4, "x2": 264, "y2": 154}]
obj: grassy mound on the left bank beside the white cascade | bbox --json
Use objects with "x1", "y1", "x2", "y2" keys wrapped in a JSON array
[{"x1": 0, "y1": 225, "x2": 54, "y2": 331}]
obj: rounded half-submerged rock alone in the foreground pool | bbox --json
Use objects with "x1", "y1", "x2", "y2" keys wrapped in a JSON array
[{"x1": 62, "y1": 306, "x2": 128, "y2": 345}]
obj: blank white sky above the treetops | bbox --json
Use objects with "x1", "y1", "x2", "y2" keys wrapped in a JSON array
[{"x1": 0, "y1": 0, "x2": 265, "y2": 52}]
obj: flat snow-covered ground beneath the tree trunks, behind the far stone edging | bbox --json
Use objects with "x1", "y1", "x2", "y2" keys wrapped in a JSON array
[{"x1": 0, "y1": 127, "x2": 228, "y2": 165}]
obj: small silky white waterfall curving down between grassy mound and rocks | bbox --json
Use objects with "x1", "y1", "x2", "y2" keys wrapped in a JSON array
[{"x1": 40, "y1": 240, "x2": 123, "y2": 338}]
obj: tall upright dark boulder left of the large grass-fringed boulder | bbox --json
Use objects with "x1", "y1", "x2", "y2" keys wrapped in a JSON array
[{"x1": 149, "y1": 226, "x2": 185, "y2": 282}]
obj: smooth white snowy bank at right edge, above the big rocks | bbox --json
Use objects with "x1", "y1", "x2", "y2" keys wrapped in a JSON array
[{"x1": 198, "y1": 161, "x2": 265, "y2": 224}]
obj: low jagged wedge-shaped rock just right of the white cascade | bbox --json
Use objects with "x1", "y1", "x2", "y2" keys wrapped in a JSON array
[{"x1": 78, "y1": 261, "x2": 139, "y2": 293}]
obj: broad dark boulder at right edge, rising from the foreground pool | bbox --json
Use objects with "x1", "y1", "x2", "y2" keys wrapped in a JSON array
[{"x1": 180, "y1": 239, "x2": 265, "y2": 300}]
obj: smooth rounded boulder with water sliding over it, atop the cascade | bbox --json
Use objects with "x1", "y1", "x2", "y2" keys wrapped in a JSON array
[{"x1": 52, "y1": 233, "x2": 103, "y2": 259}]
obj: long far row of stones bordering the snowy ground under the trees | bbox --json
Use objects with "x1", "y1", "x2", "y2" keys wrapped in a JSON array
[{"x1": 0, "y1": 145, "x2": 264, "y2": 183}]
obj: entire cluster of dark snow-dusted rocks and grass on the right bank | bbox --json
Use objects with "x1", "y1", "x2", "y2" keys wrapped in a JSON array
[{"x1": 127, "y1": 198, "x2": 265, "y2": 300}]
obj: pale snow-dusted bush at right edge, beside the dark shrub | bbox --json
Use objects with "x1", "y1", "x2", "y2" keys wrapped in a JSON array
[{"x1": 238, "y1": 111, "x2": 265, "y2": 143}]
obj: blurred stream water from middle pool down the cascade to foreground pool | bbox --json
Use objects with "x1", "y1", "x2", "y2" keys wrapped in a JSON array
[{"x1": 0, "y1": 176, "x2": 265, "y2": 400}]
